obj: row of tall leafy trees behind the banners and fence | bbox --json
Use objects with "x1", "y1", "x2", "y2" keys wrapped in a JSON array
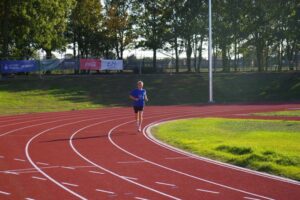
[{"x1": 0, "y1": 0, "x2": 300, "y2": 71}]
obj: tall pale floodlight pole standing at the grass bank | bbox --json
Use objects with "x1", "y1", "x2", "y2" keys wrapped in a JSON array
[{"x1": 208, "y1": 0, "x2": 214, "y2": 103}]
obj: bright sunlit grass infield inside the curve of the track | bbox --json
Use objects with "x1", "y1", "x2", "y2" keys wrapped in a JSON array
[{"x1": 153, "y1": 118, "x2": 300, "y2": 181}]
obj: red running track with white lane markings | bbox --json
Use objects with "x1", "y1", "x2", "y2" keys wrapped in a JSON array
[{"x1": 0, "y1": 104, "x2": 300, "y2": 200}]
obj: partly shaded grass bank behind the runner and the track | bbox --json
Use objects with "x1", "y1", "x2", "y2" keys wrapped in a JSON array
[{"x1": 0, "y1": 72, "x2": 300, "y2": 115}]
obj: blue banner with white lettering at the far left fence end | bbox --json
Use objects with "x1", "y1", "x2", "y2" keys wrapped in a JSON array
[{"x1": 0, "y1": 60, "x2": 39, "y2": 74}]
